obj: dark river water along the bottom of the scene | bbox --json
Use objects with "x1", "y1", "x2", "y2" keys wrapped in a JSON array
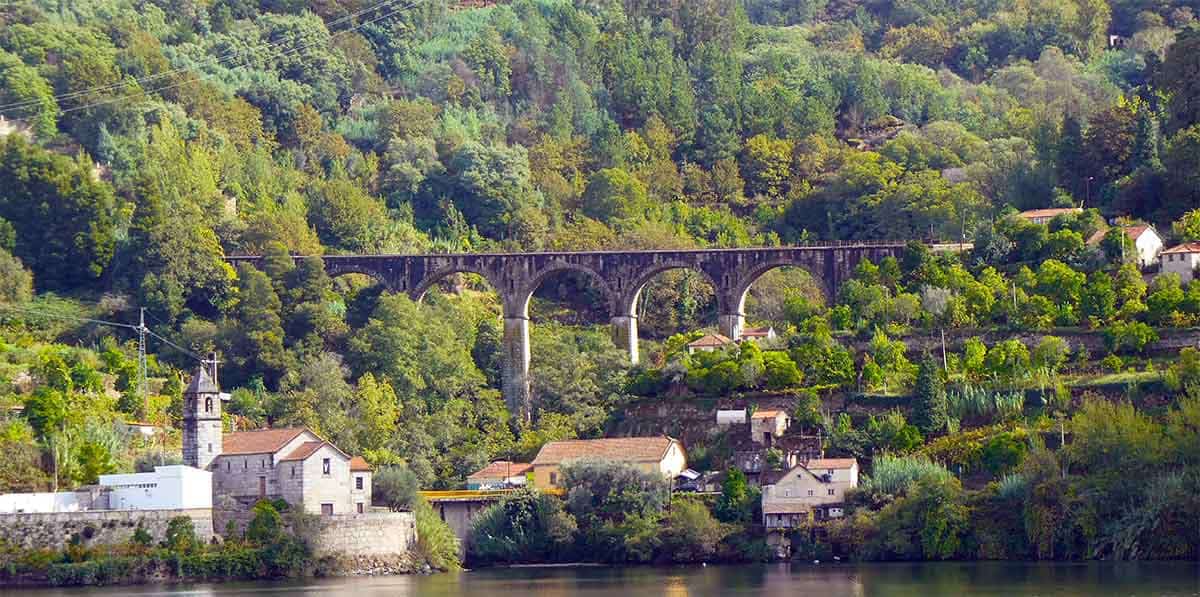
[{"x1": 9, "y1": 562, "x2": 1200, "y2": 597}]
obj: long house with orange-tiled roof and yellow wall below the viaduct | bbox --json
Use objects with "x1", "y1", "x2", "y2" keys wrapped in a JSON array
[{"x1": 533, "y1": 436, "x2": 688, "y2": 488}]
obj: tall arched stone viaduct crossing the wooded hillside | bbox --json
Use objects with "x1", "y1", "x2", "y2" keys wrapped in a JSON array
[{"x1": 227, "y1": 242, "x2": 905, "y2": 418}]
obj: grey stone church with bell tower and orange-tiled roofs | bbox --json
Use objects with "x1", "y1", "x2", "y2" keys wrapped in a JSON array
[{"x1": 184, "y1": 358, "x2": 371, "y2": 515}]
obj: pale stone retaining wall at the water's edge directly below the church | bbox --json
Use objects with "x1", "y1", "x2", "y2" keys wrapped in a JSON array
[{"x1": 296, "y1": 512, "x2": 416, "y2": 556}]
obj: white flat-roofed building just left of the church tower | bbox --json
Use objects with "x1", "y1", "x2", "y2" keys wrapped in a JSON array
[{"x1": 100, "y1": 465, "x2": 212, "y2": 509}]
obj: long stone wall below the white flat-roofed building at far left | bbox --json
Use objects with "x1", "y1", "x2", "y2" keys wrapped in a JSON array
[{"x1": 0, "y1": 508, "x2": 212, "y2": 550}]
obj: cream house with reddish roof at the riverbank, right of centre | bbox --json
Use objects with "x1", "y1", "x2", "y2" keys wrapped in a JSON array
[{"x1": 762, "y1": 458, "x2": 858, "y2": 531}]
